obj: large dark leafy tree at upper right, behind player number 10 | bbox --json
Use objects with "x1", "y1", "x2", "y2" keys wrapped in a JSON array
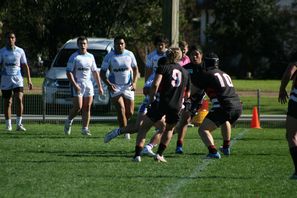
[{"x1": 207, "y1": 0, "x2": 292, "y2": 78}]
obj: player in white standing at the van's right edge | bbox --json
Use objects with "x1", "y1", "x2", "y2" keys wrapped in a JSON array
[{"x1": 100, "y1": 36, "x2": 138, "y2": 139}]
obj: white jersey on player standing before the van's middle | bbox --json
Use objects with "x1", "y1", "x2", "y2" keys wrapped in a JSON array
[{"x1": 66, "y1": 51, "x2": 97, "y2": 83}]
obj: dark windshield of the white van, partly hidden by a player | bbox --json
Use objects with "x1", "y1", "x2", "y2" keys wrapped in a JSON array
[{"x1": 53, "y1": 49, "x2": 107, "y2": 68}]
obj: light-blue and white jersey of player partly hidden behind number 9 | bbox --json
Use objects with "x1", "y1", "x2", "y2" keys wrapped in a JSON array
[{"x1": 144, "y1": 49, "x2": 167, "y2": 87}]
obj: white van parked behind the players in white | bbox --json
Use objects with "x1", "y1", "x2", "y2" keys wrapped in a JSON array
[{"x1": 43, "y1": 38, "x2": 114, "y2": 110}]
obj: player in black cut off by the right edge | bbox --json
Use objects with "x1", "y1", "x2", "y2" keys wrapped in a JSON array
[{"x1": 278, "y1": 62, "x2": 297, "y2": 179}]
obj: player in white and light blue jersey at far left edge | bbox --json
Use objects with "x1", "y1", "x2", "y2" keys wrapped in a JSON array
[{"x1": 0, "y1": 32, "x2": 33, "y2": 131}]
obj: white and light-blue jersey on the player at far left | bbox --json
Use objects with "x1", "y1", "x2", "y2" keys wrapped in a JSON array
[{"x1": 0, "y1": 46, "x2": 27, "y2": 76}]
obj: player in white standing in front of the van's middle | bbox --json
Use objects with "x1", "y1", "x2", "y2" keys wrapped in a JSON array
[{"x1": 64, "y1": 36, "x2": 103, "y2": 136}]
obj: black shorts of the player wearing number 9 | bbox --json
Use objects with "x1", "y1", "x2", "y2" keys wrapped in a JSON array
[{"x1": 146, "y1": 101, "x2": 180, "y2": 124}]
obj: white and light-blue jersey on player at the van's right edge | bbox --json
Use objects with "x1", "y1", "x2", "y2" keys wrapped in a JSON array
[{"x1": 101, "y1": 49, "x2": 137, "y2": 85}]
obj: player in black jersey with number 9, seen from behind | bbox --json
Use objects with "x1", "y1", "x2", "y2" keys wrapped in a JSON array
[{"x1": 133, "y1": 48, "x2": 190, "y2": 162}]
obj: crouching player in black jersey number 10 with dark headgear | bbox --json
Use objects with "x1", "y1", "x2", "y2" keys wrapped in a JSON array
[{"x1": 197, "y1": 52, "x2": 242, "y2": 158}]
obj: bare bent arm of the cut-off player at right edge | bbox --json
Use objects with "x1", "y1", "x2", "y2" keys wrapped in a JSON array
[{"x1": 278, "y1": 63, "x2": 297, "y2": 104}]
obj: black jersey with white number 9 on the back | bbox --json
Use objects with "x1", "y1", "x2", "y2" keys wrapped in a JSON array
[{"x1": 156, "y1": 64, "x2": 190, "y2": 109}]
